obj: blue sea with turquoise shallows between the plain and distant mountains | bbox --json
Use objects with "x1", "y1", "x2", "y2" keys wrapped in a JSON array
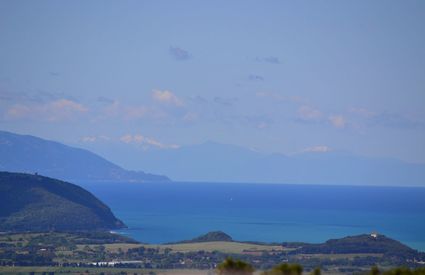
[{"x1": 80, "y1": 182, "x2": 425, "y2": 251}]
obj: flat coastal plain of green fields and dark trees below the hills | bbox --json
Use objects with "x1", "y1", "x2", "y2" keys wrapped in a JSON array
[{"x1": 0, "y1": 232, "x2": 425, "y2": 275}]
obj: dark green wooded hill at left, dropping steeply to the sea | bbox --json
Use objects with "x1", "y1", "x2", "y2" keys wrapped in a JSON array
[{"x1": 0, "y1": 172, "x2": 124, "y2": 231}]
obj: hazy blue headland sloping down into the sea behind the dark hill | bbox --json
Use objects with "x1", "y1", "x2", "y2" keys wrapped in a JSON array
[{"x1": 0, "y1": 131, "x2": 169, "y2": 182}]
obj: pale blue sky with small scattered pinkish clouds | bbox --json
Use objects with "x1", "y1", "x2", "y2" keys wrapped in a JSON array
[{"x1": 0, "y1": 0, "x2": 425, "y2": 163}]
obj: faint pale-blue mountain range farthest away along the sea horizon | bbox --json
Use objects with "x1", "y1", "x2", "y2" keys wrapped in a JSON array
[{"x1": 104, "y1": 142, "x2": 425, "y2": 186}]
